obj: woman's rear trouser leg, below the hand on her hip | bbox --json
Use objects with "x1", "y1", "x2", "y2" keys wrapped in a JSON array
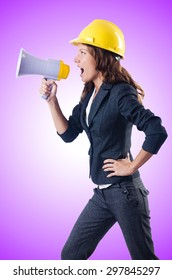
[{"x1": 106, "y1": 179, "x2": 158, "y2": 260}]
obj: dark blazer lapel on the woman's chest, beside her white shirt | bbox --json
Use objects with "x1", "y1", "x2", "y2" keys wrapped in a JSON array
[{"x1": 87, "y1": 84, "x2": 112, "y2": 125}]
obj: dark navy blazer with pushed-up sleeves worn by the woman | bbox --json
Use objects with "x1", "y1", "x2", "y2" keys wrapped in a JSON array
[{"x1": 57, "y1": 83, "x2": 167, "y2": 185}]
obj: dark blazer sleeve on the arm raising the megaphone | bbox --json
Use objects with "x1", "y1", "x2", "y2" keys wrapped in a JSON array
[{"x1": 57, "y1": 103, "x2": 83, "y2": 143}]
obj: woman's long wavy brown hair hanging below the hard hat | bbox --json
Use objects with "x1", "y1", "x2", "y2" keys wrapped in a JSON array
[{"x1": 81, "y1": 45, "x2": 144, "y2": 103}]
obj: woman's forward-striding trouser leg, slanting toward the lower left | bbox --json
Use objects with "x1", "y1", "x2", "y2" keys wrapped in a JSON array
[{"x1": 61, "y1": 189, "x2": 116, "y2": 260}]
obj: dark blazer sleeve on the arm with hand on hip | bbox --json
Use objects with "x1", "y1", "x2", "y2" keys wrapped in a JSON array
[{"x1": 118, "y1": 85, "x2": 167, "y2": 154}]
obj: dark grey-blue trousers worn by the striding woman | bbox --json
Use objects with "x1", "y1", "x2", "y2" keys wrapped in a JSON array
[{"x1": 61, "y1": 178, "x2": 158, "y2": 260}]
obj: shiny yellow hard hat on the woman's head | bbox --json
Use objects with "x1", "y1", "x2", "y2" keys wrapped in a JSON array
[{"x1": 70, "y1": 19, "x2": 125, "y2": 57}]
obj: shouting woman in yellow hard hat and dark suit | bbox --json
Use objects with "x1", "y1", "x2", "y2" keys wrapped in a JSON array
[{"x1": 40, "y1": 20, "x2": 167, "y2": 260}]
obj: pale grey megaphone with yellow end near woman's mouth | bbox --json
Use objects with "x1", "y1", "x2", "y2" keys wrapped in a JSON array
[{"x1": 16, "y1": 49, "x2": 70, "y2": 81}]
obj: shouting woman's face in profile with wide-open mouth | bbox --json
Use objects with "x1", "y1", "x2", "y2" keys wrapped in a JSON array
[{"x1": 74, "y1": 44, "x2": 102, "y2": 86}]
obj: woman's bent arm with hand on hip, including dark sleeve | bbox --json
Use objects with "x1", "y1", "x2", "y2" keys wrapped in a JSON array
[{"x1": 103, "y1": 86, "x2": 167, "y2": 177}]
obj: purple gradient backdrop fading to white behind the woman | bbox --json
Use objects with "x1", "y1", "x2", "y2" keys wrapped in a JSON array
[{"x1": 0, "y1": 0, "x2": 172, "y2": 260}]
